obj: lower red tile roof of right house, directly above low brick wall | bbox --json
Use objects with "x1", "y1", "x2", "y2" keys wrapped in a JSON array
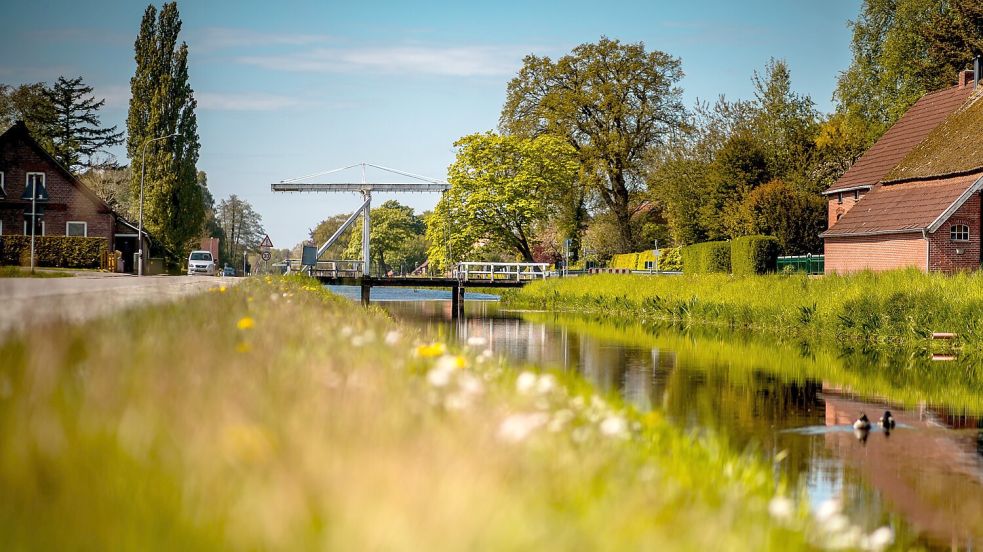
[{"x1": 822, "y1": 172, "x2": 983, "y2": 237}]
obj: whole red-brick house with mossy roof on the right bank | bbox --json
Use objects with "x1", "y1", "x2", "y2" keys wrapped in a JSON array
[{"x1": 822, "y1": 71, "x2": 983, "y2": 273}]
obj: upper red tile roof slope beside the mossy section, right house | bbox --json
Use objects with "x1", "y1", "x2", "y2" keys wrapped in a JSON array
[{"x1": 825, "y1": 86, "x2": 973, "y2": 195}]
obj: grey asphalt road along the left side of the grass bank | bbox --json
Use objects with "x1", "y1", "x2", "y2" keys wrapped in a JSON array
[{"x1": 0, "y1": 272, "x2": 238, "y2": 334}]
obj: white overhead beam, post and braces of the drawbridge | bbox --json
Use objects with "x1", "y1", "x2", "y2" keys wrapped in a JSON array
[{"x1": 270, "y1": 163, "x2": 450, "y2": 277}]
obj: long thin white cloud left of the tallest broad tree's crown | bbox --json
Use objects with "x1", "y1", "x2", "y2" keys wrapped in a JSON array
[{"x1": 237, "y1": 46, "x2": 528, "y2": 77}]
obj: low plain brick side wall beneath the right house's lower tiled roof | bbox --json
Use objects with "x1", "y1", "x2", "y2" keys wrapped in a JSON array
[{"x1": 825, "y1": 233, "x2": 925, "y2": 274}]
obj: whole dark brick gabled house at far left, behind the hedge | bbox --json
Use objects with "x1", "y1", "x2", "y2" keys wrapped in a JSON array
[{"x1": 0, "y1": 121, "x2": 150, "y2": 272}]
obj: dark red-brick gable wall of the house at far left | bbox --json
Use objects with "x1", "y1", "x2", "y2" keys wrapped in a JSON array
[{"x1": 0, "y1": 129, "x2": 113, "y2": 247}]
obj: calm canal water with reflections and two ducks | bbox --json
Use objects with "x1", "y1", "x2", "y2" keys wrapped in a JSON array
[{"x1": 335, "y1": 288, "x2": 983, "y2": 549}]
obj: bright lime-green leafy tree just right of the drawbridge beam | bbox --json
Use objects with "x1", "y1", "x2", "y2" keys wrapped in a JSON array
[{"x1": 427, "y1": 132, "x2": 577, "y2": 268}]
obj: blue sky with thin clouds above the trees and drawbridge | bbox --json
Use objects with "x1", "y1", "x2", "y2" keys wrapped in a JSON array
[{"x1": 0, "y1": 0, "x2": 860, "y2": 247}]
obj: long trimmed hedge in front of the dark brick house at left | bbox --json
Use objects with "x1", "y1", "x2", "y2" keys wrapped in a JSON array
[{"x1": 0, "y1": 236, "x2": 109, "y2": 268}]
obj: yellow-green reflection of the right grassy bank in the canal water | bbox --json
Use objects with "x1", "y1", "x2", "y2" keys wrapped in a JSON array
[{"x1": 524, "y1": 313, "x2": 983, "y2": 414}]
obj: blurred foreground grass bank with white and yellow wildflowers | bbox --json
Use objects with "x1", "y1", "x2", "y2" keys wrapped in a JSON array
[{"x1": 0, "y1": 278, "x2": 868, "y2": 550}]
